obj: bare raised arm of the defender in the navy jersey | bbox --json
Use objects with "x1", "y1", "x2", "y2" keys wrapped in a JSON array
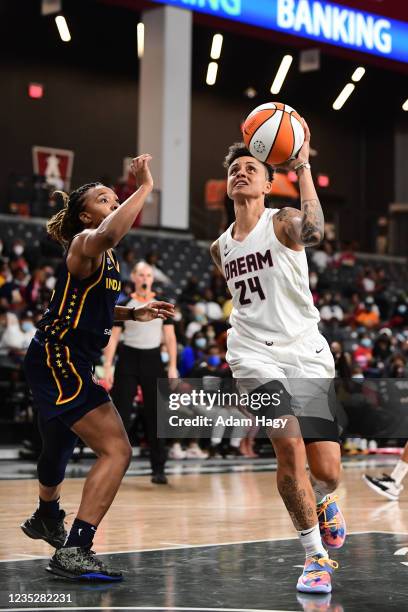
[{"x1": 75, "y1": 154, "x2": 153, "y2": 258}]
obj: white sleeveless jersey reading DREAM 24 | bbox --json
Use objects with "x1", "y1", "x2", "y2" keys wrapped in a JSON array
[{"x1": 218, "y1": 208, "x2": 320, "y2": 342}]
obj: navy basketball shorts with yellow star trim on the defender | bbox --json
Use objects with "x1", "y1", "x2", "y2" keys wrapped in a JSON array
[{"x1": 24, "y1": 338, "x2": 111, "y2": 427}]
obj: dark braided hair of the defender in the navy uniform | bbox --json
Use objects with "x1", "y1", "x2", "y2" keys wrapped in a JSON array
[{"x1": 47, "y1": 183, "x2": 100, "y2": 246}]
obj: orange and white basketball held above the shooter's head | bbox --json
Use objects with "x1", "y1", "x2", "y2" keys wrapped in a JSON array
[{"x1": 242, "y1": 102, "x2": 305, "y2": 165}]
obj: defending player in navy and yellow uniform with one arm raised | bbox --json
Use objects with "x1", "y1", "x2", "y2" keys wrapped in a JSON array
[{"x1": 21, "y1": 155, "x2": 173, "y2": 581}]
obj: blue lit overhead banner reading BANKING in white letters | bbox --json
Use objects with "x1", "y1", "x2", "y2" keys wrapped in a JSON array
[{"x1": 153, "y1": 0, "x2": 408, "y2": 62}]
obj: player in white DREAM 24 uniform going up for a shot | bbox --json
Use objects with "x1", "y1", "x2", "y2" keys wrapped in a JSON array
[{"x1": 211, "y1": 122, "x2": 346, "y2": 593}]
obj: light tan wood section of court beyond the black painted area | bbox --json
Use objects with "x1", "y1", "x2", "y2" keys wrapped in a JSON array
[{"x1": 0, "y1": 467, "x2": 408, "y2": 561}]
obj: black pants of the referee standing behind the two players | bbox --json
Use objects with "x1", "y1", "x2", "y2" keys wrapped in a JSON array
[{"x1": 111, "y1": 344, "x2": 166, "y2": 472}]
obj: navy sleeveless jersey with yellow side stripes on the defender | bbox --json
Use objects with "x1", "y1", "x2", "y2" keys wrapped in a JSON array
[{"x1": 37, "y1": 250, "x2": 121, "y2": 361}]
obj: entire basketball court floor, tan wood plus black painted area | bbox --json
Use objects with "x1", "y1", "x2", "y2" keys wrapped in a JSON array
[{"x1": 0, "y1": 457, "x2": 408, "y2": 612}]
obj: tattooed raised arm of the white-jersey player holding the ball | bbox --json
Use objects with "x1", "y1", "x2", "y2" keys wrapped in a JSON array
[{"x1": 276, "y1": 120, "x2": 324, "y2": 246}]
